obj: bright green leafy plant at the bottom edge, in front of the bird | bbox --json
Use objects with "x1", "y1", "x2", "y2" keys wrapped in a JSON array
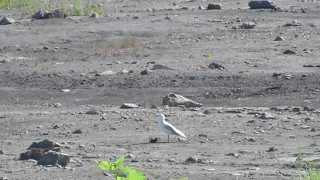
[{"x1": 97, "y1": 157, "x2": 147, "y2": 180}]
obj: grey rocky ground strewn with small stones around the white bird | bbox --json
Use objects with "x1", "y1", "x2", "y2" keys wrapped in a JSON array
[{"x1": 0, "y1": 0, "x2": 320, "y2": 180}]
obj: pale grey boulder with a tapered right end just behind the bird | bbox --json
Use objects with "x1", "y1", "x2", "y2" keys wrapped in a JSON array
[{"x1": 162, "y1": 93, "x2": 203, "y2": 107}]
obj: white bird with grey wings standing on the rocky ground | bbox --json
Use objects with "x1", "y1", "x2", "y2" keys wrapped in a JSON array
[{"x1": 156, "y1": 113, "x2": 187, "y2": 142}]
